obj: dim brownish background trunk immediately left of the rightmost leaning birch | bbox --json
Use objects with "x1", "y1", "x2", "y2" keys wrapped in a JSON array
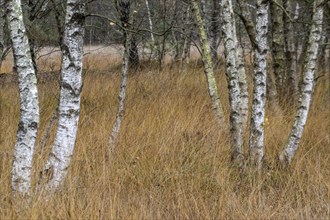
[{"x1": 284, "y1": 0, "x2": 298, "y2": 103}]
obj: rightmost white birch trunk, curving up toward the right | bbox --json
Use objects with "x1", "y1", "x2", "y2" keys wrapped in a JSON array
[{"x1": 280, "y1": 0, "x2": 324, "y2": 164}]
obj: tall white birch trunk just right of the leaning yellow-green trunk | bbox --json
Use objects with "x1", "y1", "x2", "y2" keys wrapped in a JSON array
[{"x1": 221, "y1": 0, "x2": 243, "y2": 161}]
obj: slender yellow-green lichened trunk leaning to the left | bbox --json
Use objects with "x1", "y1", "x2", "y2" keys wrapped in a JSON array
[{"x1": 191, "y1": 0, "x2": 224, "y2": 127}]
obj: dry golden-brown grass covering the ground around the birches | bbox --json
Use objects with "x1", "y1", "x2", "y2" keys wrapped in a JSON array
[{"x1": 0, "y1": 54, "x2": 330, "y2": 219}]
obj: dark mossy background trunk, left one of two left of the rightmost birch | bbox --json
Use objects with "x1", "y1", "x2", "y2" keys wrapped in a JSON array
[{"x1": 270, "y1": 0, "x2": 285, "y2": 94}]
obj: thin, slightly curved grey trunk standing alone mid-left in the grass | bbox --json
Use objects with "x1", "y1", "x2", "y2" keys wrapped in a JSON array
[{"x1": 109, "y1": 32, "x2": 131, "y2": 151}]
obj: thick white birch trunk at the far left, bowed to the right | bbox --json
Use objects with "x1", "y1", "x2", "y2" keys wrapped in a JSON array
[{"x1": 6, "y1": 0, "x2": 39, "y2": 194}]
